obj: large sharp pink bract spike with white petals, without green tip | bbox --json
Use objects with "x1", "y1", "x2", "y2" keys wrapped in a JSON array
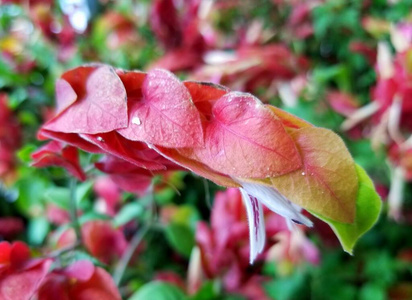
[{"x1": 33, "y1": 65, "x2": 358, "y2": 261}]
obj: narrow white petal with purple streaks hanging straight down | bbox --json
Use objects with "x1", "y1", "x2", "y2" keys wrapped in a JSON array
[{"x1": 240, "y1": 189, "x2": 266, "y2": 264}]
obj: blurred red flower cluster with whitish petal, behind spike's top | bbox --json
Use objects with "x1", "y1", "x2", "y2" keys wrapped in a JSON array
[{"x1": 191, "y1": 44, "x2": 309, "y2": 101}]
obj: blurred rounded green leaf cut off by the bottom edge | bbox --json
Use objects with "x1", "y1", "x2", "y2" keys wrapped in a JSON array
[{"x1": 129, "y1": 281, "x2": 186, "y2": 300}]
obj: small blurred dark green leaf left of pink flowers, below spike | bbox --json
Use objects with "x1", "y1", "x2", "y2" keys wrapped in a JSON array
[{"x1": 165, "y1": 223, "x2": 195, "y2": 258}]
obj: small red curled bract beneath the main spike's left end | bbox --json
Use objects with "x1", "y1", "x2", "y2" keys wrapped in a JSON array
[{"x1": 31, "y1": 141, "x2": 86, "y2": 181}]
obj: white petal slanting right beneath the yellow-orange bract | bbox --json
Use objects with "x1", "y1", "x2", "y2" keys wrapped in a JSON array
[{"x1": 241, "y1": 182, "x2": 312, "y2": 227}]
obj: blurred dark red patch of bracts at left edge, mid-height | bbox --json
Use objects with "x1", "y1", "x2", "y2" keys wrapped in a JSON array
[{"x1": 0, "y1": 93, "x2": 21, "y2": 180}]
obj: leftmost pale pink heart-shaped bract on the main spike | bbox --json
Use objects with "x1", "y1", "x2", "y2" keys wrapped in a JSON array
[{"x1": 43, "y1": 66, "x2": 127, "y2": 134}]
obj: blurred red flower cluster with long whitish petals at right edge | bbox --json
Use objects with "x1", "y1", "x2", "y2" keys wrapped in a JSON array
[{"x1": 342, "y1": 27, "x2": 412, "y2": 220}]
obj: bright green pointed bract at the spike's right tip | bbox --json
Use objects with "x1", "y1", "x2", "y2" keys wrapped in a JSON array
[{"x1": 310, "y1": 165, "x2": 382, "y2": 254}]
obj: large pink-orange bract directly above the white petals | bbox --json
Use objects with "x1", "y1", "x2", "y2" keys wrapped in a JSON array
[{"x1": 194, "y1": 92, "x2": 302, "y2": 178}]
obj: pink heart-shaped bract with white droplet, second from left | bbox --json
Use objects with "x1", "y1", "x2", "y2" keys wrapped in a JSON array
[{"x1": 118, "y1": 70, "x2": 203, "y2": 148}]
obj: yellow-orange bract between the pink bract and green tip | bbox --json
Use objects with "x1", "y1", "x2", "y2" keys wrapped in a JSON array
[{"x1": 271, "y1": 127, "x2": 358, "y2": 223}]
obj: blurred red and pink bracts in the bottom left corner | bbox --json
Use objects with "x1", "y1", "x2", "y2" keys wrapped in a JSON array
[{"x1": 0, "y1": 242, "x2": 52, "y2": 300}]
